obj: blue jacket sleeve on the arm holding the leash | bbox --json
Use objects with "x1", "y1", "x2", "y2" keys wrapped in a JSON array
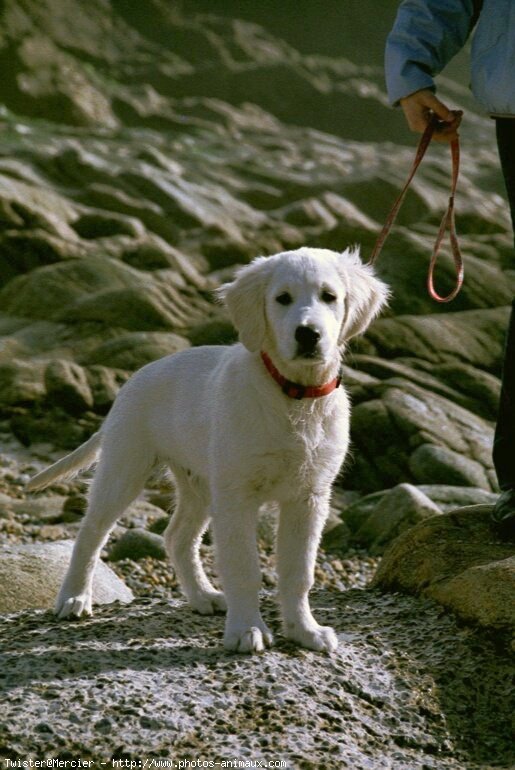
[{"x1": 385, "y1": 0, "x2": 475, "y2": 105}]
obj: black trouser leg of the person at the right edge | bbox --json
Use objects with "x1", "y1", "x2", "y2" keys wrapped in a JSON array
[{"x1": 493, "y1": 118, "x2": 515, "y2": 489}]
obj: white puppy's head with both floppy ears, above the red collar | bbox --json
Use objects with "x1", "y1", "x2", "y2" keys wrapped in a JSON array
[{"x1": 218, "y1": 247, "x2": 388, "y2": 365}]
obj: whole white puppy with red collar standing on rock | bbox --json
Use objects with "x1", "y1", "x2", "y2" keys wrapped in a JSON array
[{"x1": 29, "y1": 248, "x2": 388, "y2": 652}]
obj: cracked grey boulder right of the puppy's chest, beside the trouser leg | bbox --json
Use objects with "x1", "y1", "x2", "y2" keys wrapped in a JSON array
[{"x1": 343, "y1": 378, "x2": 497, "y2": 492}]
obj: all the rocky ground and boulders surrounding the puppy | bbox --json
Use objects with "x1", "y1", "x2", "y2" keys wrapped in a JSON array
[{"x1": 0, "y1": 0, "x2": 515, "y2": 770}]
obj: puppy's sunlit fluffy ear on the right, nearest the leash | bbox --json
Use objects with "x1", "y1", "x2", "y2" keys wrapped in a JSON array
[{"x1": 339, "y1": 248, "x2": 390, "y2": 345}]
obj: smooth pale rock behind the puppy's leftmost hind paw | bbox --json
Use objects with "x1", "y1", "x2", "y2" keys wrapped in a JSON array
[{"x1": 0, "y1": 541, "x2": 133, "y2": 613}]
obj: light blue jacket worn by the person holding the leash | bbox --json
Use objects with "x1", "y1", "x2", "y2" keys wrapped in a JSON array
[{"x1": 385, "y1": 0, "x2": 515, "y2": 117}]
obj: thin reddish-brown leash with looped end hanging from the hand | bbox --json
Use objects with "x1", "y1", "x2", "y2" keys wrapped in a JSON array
[{"x1": 369, "y1": 115, "x2": 464, "y2": 302}]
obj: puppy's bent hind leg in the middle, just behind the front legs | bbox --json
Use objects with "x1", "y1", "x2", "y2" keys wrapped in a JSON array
[{"x1": 164, "y1": 470, "x2": 226, "y2": 615}]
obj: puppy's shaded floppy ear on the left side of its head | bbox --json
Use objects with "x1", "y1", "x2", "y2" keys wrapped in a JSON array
[{"x1": 216, "y1": 257, "x2": 271, "y2": 353}]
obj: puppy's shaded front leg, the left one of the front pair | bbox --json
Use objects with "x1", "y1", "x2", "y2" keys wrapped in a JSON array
[{"x1": 212, "y1": 493, "x2": 273, "y2": 652}]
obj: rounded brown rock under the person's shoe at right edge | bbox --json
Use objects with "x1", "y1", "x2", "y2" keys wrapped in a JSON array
[{"x1": 373, "y1": 505, "x2": 515, "y2": 633}]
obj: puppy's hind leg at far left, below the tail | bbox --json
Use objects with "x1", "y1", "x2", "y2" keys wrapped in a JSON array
[{"x1": 55, "y1": 446, "x2": 152, "y2": 618}]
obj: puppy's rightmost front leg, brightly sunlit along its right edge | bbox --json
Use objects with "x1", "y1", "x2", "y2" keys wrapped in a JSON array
[{"x1": 277, "y1": 494, "x2": 338, "y2": 652}]
